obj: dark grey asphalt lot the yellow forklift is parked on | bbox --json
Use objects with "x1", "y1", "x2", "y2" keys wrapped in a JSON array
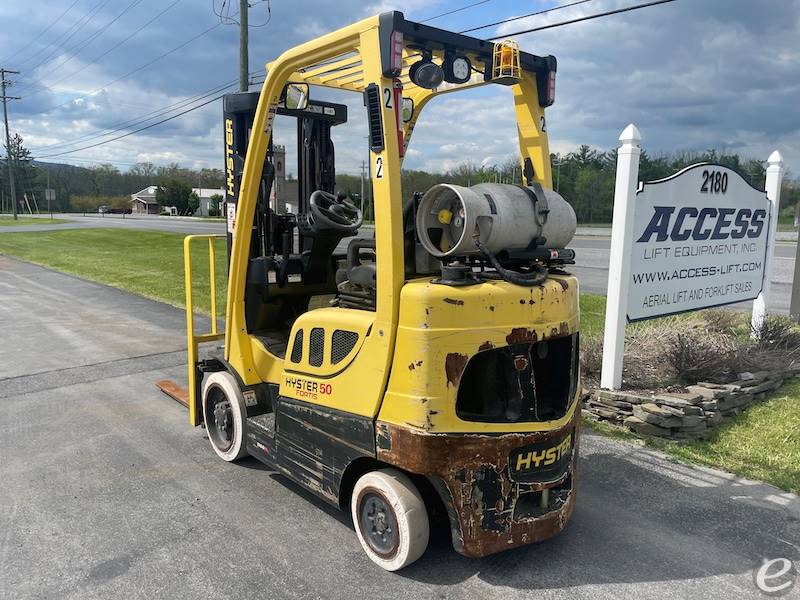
[{"x1": 0, "y1": 256, "x2": 800, "y2": 600}]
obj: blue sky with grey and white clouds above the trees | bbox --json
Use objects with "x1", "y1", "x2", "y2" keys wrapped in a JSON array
[{"x1": 0, "y1": 0, "x2": 800, "y2": 174}]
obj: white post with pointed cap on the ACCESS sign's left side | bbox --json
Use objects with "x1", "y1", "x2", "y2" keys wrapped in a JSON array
[{"x1": 600, "y1": 123, "x2": 642, "y2": 390}]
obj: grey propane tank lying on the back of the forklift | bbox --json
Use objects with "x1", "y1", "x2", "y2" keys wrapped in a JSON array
[{"x1": 417, "y1": 183, "x2": 577, "y2": 258}]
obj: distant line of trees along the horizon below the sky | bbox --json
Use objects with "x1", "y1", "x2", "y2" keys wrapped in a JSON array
[{"x1": 0, "y1": 135, "x2": 800, "y2": 223}]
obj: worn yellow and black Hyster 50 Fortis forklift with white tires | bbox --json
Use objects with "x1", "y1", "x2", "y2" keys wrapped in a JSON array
[{"x1": 169, "y1": 12, "x2": 580, "y2": 570}]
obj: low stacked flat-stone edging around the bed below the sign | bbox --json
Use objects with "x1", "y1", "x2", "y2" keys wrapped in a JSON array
[{"x1": 583, "y1": 365, "x2": 800, "y2": 440}]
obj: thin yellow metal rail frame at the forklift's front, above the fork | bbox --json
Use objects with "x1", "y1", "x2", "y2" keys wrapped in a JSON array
[{"x1": 183, "y1": 234, "x2": 225, "y2": 426}]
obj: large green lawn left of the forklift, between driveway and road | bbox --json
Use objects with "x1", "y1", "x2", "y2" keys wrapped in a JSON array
[{"x1": 0, "y1": 229, "x2": 228, "y2": 314}]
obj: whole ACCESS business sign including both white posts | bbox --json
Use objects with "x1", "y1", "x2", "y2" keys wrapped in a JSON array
[{"x1": 600, "y1": 125, "x2": 783, "y2": 390}]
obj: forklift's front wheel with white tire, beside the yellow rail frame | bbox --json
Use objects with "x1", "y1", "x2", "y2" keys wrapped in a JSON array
[{"x1": 203, "y1": 371, "x2": 247, "y2": 462}]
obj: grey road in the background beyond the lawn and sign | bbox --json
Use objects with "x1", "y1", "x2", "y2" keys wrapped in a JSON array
[{"x1": 0, "y1": 214, "x2": 797, "y2": 313}]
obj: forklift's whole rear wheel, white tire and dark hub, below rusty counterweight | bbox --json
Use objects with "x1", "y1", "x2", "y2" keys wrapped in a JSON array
[{"x1": 350, "y1": 469, "x2": 430, "y2": 571}]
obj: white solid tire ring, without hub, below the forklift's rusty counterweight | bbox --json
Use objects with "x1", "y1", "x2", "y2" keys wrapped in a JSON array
[{"x1": 350, "y1": 469, "x2": 430, "y2": 571}]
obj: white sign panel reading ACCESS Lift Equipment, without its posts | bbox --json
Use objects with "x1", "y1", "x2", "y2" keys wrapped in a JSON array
[{"x1": 628, "y1": 163, "x2": 770, "y2": 321}]
